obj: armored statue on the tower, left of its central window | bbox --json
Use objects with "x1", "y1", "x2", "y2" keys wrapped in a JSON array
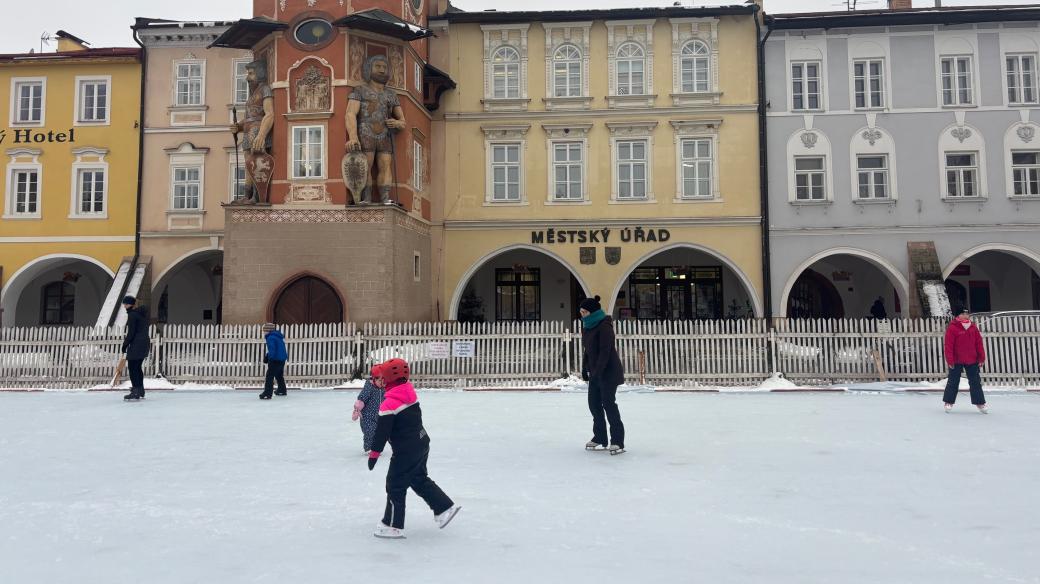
[{"x1": 231, "y1": 59, "x2": 275, "y2": 205}]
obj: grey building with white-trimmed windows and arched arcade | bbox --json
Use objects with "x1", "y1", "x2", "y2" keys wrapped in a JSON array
[{"x1": 764, "y1": 5, "x2": 1040, "y2": 318}]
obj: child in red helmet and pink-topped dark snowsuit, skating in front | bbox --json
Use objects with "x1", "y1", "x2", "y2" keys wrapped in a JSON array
[{"x1": 368, "y1": 359, "x2": 462, "y2": 538}]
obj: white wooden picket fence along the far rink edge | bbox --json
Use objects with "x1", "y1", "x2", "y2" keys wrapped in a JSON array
[{"x1": 0, "y1": 318, "x2": 1040, "y2": 389}]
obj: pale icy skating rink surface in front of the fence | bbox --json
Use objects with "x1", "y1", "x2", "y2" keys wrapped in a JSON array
[{"x1": 0, "y1": 391, "x2": 1040, "y2": 584}]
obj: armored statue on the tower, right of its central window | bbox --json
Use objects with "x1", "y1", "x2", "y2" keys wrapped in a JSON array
[{"x1": 346, "y1": 55, "x2": 406, "y2": 204}]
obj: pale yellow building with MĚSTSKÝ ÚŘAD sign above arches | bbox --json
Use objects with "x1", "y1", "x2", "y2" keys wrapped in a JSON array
[{"x1": 431, "y1": 2, "x2": 763, "y2": 321}]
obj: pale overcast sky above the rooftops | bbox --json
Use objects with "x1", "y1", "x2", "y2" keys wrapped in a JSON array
[{"x1": 0, "y1": 0, "x2": 1030, "y2": 53}]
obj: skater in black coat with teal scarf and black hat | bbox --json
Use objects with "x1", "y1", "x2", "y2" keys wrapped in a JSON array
[{"x1": 578, "y1": 296, "x2": 625, "y2": 454}]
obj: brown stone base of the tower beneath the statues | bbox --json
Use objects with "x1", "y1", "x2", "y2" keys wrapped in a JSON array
[{"x1": 223, "y1": 206, "x2": 432, "y2": 324}]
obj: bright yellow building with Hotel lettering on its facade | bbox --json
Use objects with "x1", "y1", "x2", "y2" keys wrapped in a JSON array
[{"x1": 0, "y1": 32, "x2": 141, "y2": 326}]
